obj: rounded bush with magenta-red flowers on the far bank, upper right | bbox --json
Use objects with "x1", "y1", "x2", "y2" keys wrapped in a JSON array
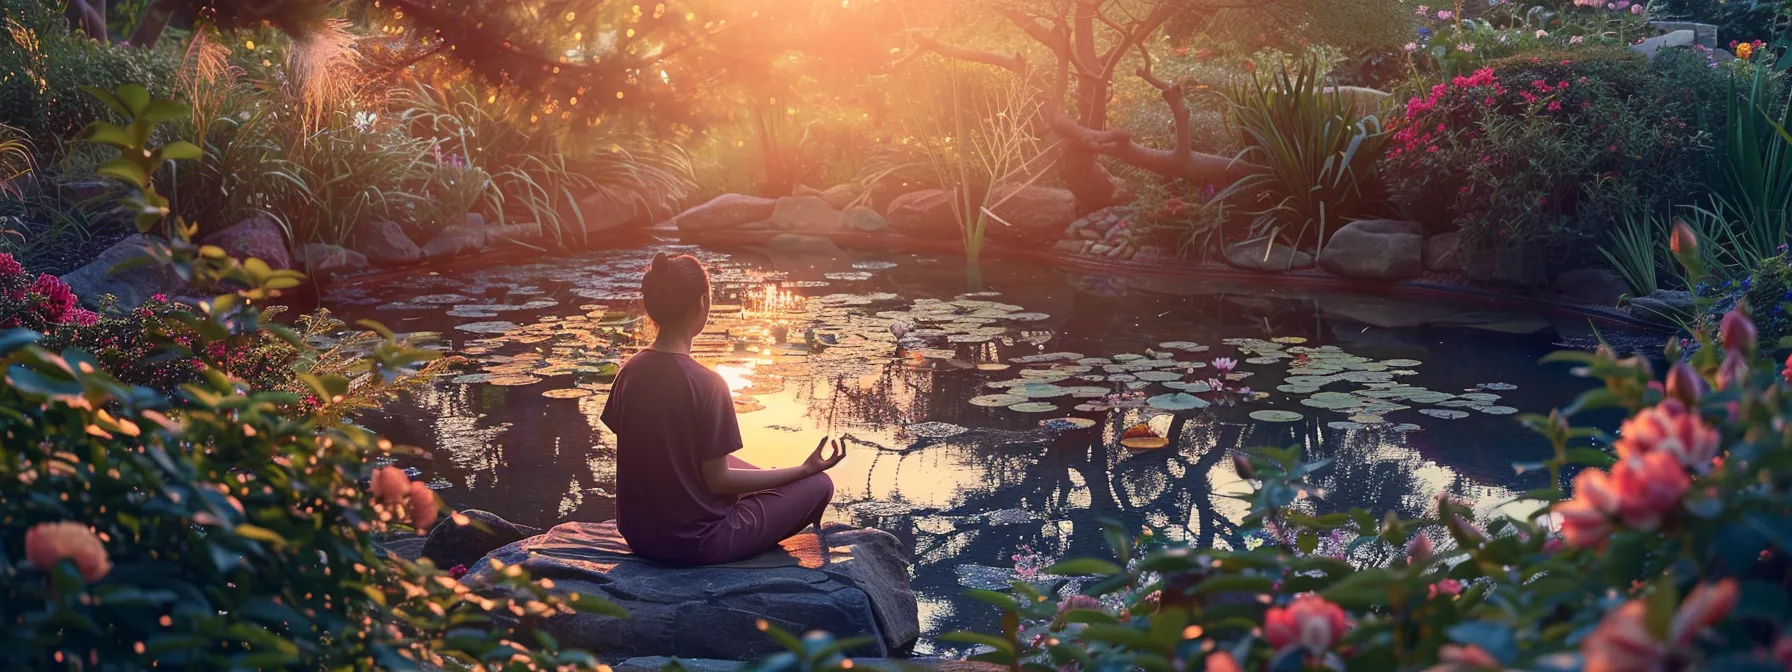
[{"x1": 1383, "y1": 50, "x2": 1724, "y2": 262}]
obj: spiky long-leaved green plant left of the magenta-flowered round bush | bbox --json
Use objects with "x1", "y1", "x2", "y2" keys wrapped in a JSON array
[{"x1": 1228, "y1": 59, "x2": 1389, "y2": 247}]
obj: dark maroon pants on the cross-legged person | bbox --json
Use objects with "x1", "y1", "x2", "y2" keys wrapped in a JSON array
[{"x1": 679, "y1": 455, "x2": 833, "y2": 564}]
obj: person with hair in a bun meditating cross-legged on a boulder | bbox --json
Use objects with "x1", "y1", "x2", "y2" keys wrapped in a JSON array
[{"x1": 602, "y1": 253, "x2": 846, "y2": 566}]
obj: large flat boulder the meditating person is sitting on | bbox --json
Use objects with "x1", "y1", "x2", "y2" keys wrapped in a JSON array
[{"x1": 462, "y1": 521, "x2": 921, "y2": 659}]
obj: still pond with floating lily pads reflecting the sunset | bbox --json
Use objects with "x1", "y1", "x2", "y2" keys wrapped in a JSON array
[{"x1": 326, "y1": 246, "x2": 1627, "y2": 652}]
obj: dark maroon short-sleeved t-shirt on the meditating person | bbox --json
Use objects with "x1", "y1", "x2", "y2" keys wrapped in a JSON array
[{"x1": 602, "y1": 349, "x2": 740, "y2": 557}]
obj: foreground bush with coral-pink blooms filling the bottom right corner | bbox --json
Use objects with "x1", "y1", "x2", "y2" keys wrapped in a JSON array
[{"x1": 896, "y1": 231, "x2": 1792, "y2": 670}]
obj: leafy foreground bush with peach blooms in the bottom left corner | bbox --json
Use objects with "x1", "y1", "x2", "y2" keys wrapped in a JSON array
[{"x1": 0, "y1": 82, "x2": 615, "y2": 670}]
